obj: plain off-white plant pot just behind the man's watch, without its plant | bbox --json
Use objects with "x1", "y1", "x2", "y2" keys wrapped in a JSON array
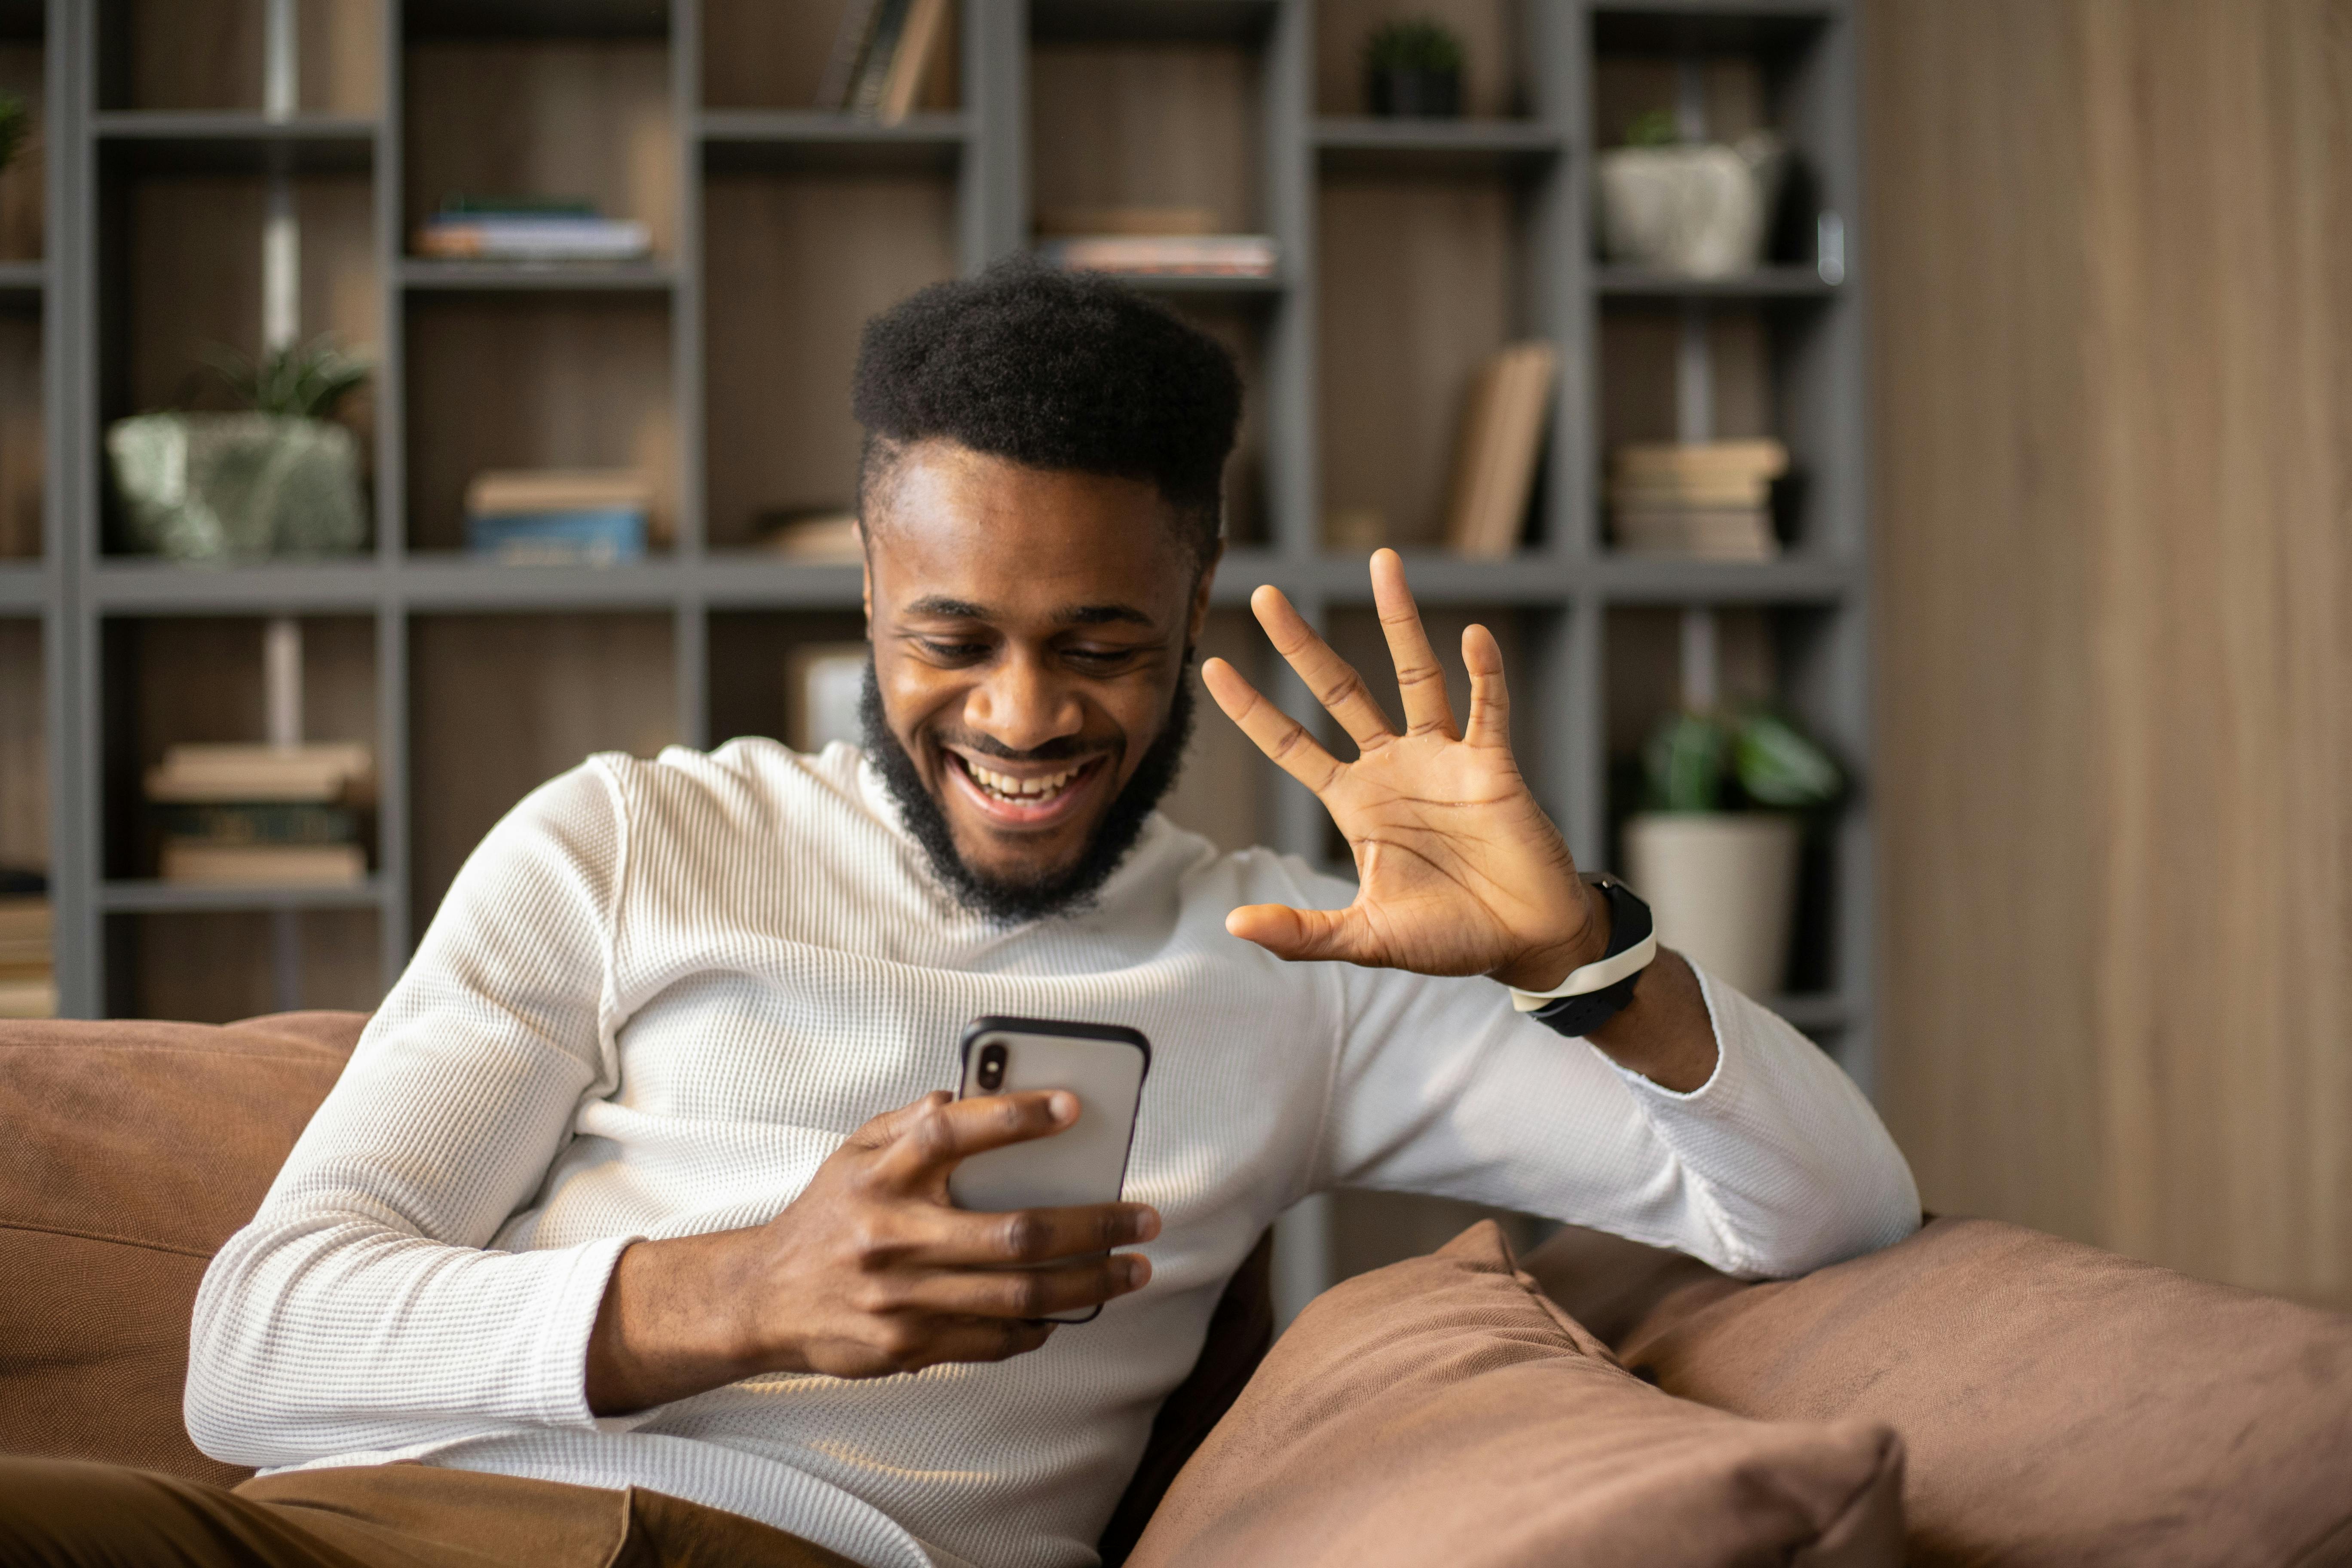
[{"x1": 1625, "y1": 811, "x2": 1799, "y2": 997}]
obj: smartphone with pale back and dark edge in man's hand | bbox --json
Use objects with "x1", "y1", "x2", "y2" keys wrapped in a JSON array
[{"x1": 948, "y1": 1016, "x2": 1152, "y2": 1323}]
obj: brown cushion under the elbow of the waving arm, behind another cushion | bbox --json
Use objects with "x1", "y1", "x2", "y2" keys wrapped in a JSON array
[{"x1": 1529, "y1": 1218, "x2": 2352, "y2": 1568}]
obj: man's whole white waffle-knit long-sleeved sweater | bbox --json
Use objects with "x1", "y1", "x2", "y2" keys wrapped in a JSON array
[{"x1": 186, "y1": 741, "x2": 1919, "y2": 1568}]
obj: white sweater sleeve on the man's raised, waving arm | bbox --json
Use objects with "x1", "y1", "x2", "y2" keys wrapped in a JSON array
[{"x1": 1324, "y1": 949, "x2": 1919, "y2": 1279}]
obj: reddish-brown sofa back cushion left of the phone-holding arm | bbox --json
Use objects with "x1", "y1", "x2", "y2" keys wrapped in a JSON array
[{"x1": 0, "y1": 1013, "x2": 367, "y2": 1483}]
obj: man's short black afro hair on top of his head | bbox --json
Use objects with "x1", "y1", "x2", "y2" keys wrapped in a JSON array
[{"x1": 851, "y1": 256, "x2": 1242, "y2": 557}]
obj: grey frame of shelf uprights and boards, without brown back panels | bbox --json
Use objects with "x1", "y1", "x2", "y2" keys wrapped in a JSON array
[{"x1": 32, "y1": 0, "x2": 1874, "y2": 1088}]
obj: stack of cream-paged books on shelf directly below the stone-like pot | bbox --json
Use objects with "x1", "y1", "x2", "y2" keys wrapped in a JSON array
[{"x1": 1609, "y1": 440, "x2": 1788, "y2": 562}]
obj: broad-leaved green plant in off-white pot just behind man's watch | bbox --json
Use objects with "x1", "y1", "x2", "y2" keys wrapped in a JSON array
[{"x1": 1625, "y1": 707, "x2": 1844, "y2": 997}]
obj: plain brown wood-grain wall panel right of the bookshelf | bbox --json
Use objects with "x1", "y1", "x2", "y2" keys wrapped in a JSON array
[{"x1": 1863, "y1": 0, "x2": 2352, "y2": 1302}]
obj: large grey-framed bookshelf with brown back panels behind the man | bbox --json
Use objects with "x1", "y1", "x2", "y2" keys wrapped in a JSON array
[{"x1": 32, "y1": 0, "x2": 1872, "y2": 1298}]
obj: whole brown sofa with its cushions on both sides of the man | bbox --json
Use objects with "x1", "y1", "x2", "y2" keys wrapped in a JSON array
[{"x1": 14, "y1": 1013, "x2": 2352, "y2": 1568}]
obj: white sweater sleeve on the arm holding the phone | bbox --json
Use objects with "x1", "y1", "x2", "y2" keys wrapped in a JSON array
[{"x1": 186, "y1": 762, "x2": 630, "y2": 1464}]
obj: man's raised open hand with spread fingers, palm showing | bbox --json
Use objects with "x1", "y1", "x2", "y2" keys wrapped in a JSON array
[{"x1": 1202, "y1": 550, "x2": 1606, "y2": 990}]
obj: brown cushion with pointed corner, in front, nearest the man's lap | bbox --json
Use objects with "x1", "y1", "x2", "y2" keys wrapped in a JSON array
[{"x1": 1129, "y1": 1222, "x2": 1903, "y2": 1568}]
